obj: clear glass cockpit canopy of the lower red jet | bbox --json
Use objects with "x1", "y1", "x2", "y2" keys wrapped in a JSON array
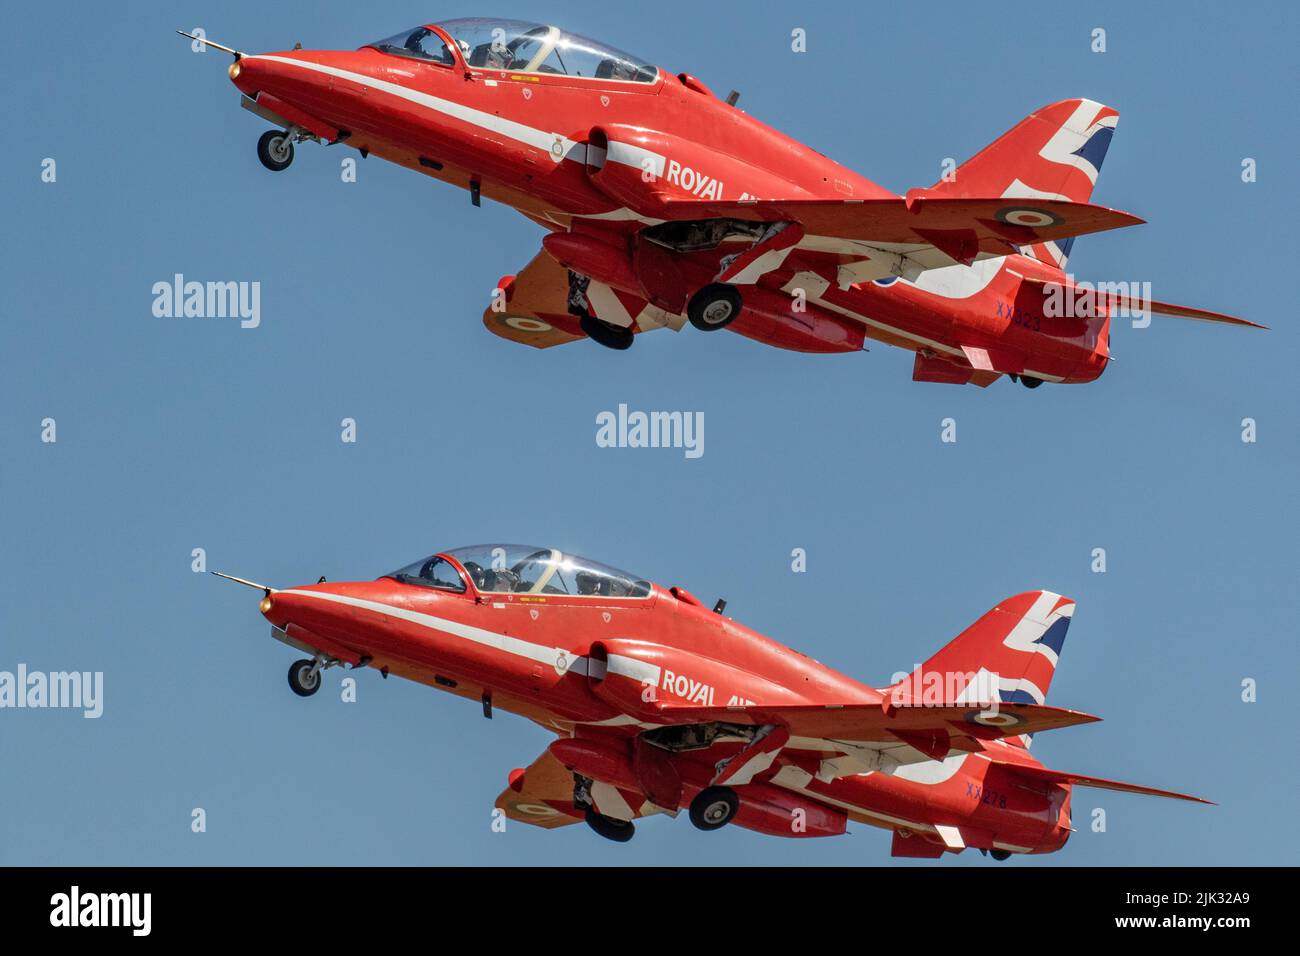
[{"x1": 384, "y1": 545, "x2": 650, "y2": 598}]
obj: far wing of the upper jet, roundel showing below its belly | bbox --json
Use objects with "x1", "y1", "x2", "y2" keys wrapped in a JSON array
[{"x1": 484, "y1": 250, "x2": 685, "y2": 349}]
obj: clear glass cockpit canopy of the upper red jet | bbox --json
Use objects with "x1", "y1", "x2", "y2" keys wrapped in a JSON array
[{"x1": 367, "y1": 17, "x2": 659, "y2": 83}]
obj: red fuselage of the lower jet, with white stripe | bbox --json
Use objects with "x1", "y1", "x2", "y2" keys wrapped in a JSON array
[{"x1": 263, "y1": 554, "x2": 1070, "y2": 856}]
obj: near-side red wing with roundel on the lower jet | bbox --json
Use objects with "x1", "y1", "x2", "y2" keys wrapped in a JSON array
[{"x1": 658, "y1": 702, "x2": 1101, "y2": 757}]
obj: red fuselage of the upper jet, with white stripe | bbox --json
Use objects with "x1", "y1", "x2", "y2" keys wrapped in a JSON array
[{"x1": 223, "y1": 25, "x2": 1109, "y2": 384}]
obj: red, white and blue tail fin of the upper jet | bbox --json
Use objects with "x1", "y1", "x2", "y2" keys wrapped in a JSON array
[{"x1": 920, "y1": 99, "x2": 1119, "y2": 269}]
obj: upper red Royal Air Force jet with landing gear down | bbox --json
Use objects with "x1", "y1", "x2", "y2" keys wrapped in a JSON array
[{"x1": 185, "y1": 18, "x2": 1262, "y2": 388}]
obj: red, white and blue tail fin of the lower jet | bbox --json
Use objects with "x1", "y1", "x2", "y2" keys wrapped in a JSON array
[{"x1": 891, "y1": 591, "x2": 1074, "y2": 704}]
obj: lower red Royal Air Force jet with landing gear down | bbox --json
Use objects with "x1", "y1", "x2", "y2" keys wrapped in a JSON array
[{"x1": 215, "y1": 545, "x2": 1209, "y2": 860}]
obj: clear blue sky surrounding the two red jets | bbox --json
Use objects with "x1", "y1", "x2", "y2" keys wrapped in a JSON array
[{"x1": 0, "y1": 0, "x2": 1300, "y2": 866}]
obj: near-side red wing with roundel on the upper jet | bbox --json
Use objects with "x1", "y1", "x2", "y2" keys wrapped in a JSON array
[{"x1": 663, "y1": 196, "x2": 1143, "y2": 268}]
